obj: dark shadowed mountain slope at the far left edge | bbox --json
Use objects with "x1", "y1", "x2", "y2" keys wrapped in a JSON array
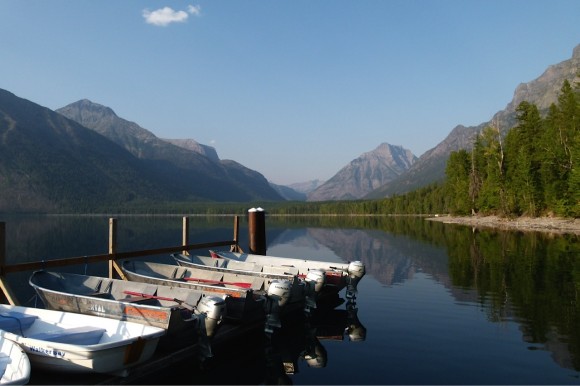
[{"x1": 0, "y1": 89, "x2": 170, "y2": 212}]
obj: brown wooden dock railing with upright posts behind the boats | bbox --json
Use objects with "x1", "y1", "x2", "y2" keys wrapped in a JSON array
[{"x1": 0, "y1": 216, "x2": 242, "y2": 305}]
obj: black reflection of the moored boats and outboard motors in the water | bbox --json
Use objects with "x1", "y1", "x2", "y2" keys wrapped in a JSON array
[{"x1": 196, "y1": 299, "x2": 366, "y2": 385}]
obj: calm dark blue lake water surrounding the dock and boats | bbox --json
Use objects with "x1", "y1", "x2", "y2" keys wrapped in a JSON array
[{"x1": 0, "y1": 216, "x2": 580, "y2": 385}]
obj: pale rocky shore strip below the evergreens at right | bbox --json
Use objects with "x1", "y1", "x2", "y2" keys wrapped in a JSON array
[{"x1": 427, "y1": 216, "x2": 580, "y2": 235}]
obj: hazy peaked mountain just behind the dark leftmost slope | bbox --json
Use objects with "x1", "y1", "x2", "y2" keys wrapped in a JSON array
[{"x1": 56, "y1": 99, "x2": 283, "y2": 202}]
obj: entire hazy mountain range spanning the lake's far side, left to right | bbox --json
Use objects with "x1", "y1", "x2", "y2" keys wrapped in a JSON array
[{"x1": 0, "y1": 45, "x2": 580, "y2": 212}]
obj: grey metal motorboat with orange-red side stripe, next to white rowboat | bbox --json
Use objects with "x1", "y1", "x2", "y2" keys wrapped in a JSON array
[{"x1": 29, "y1": 270, "x2": 225, "y2": 351}]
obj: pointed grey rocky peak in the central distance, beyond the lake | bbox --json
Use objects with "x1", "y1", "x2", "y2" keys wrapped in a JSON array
[{"x1": 308, "y1": 143, "x2": 417, "y2": 201}]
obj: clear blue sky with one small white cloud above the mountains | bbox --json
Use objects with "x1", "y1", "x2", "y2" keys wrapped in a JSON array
[{"x1": 0, "y1": 0, "x2": 580, "y2": 185}]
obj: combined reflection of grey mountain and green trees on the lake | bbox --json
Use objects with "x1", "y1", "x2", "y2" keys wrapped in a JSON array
[{"x1": 270, "y1": 217, "x2": 580, "y2": 370}]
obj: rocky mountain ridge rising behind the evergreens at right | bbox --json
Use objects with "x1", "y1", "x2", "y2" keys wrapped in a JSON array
[{"x1": 365, "y1": 45, "x2": 580, "y2": 199}]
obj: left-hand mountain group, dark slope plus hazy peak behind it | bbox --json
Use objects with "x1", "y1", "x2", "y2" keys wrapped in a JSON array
[{"x1": 0, "y1": 89, "x2": 283, "y2": 212}]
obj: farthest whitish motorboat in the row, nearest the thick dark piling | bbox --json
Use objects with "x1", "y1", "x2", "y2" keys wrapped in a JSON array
[{"x1": 209, "y1": 250, "x2": 365, "y2": 300}]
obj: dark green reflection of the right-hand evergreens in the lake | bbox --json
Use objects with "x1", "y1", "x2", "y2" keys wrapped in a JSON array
[{"x1": 449, "y1": 228, "x2": 580, "y2": 369}]
